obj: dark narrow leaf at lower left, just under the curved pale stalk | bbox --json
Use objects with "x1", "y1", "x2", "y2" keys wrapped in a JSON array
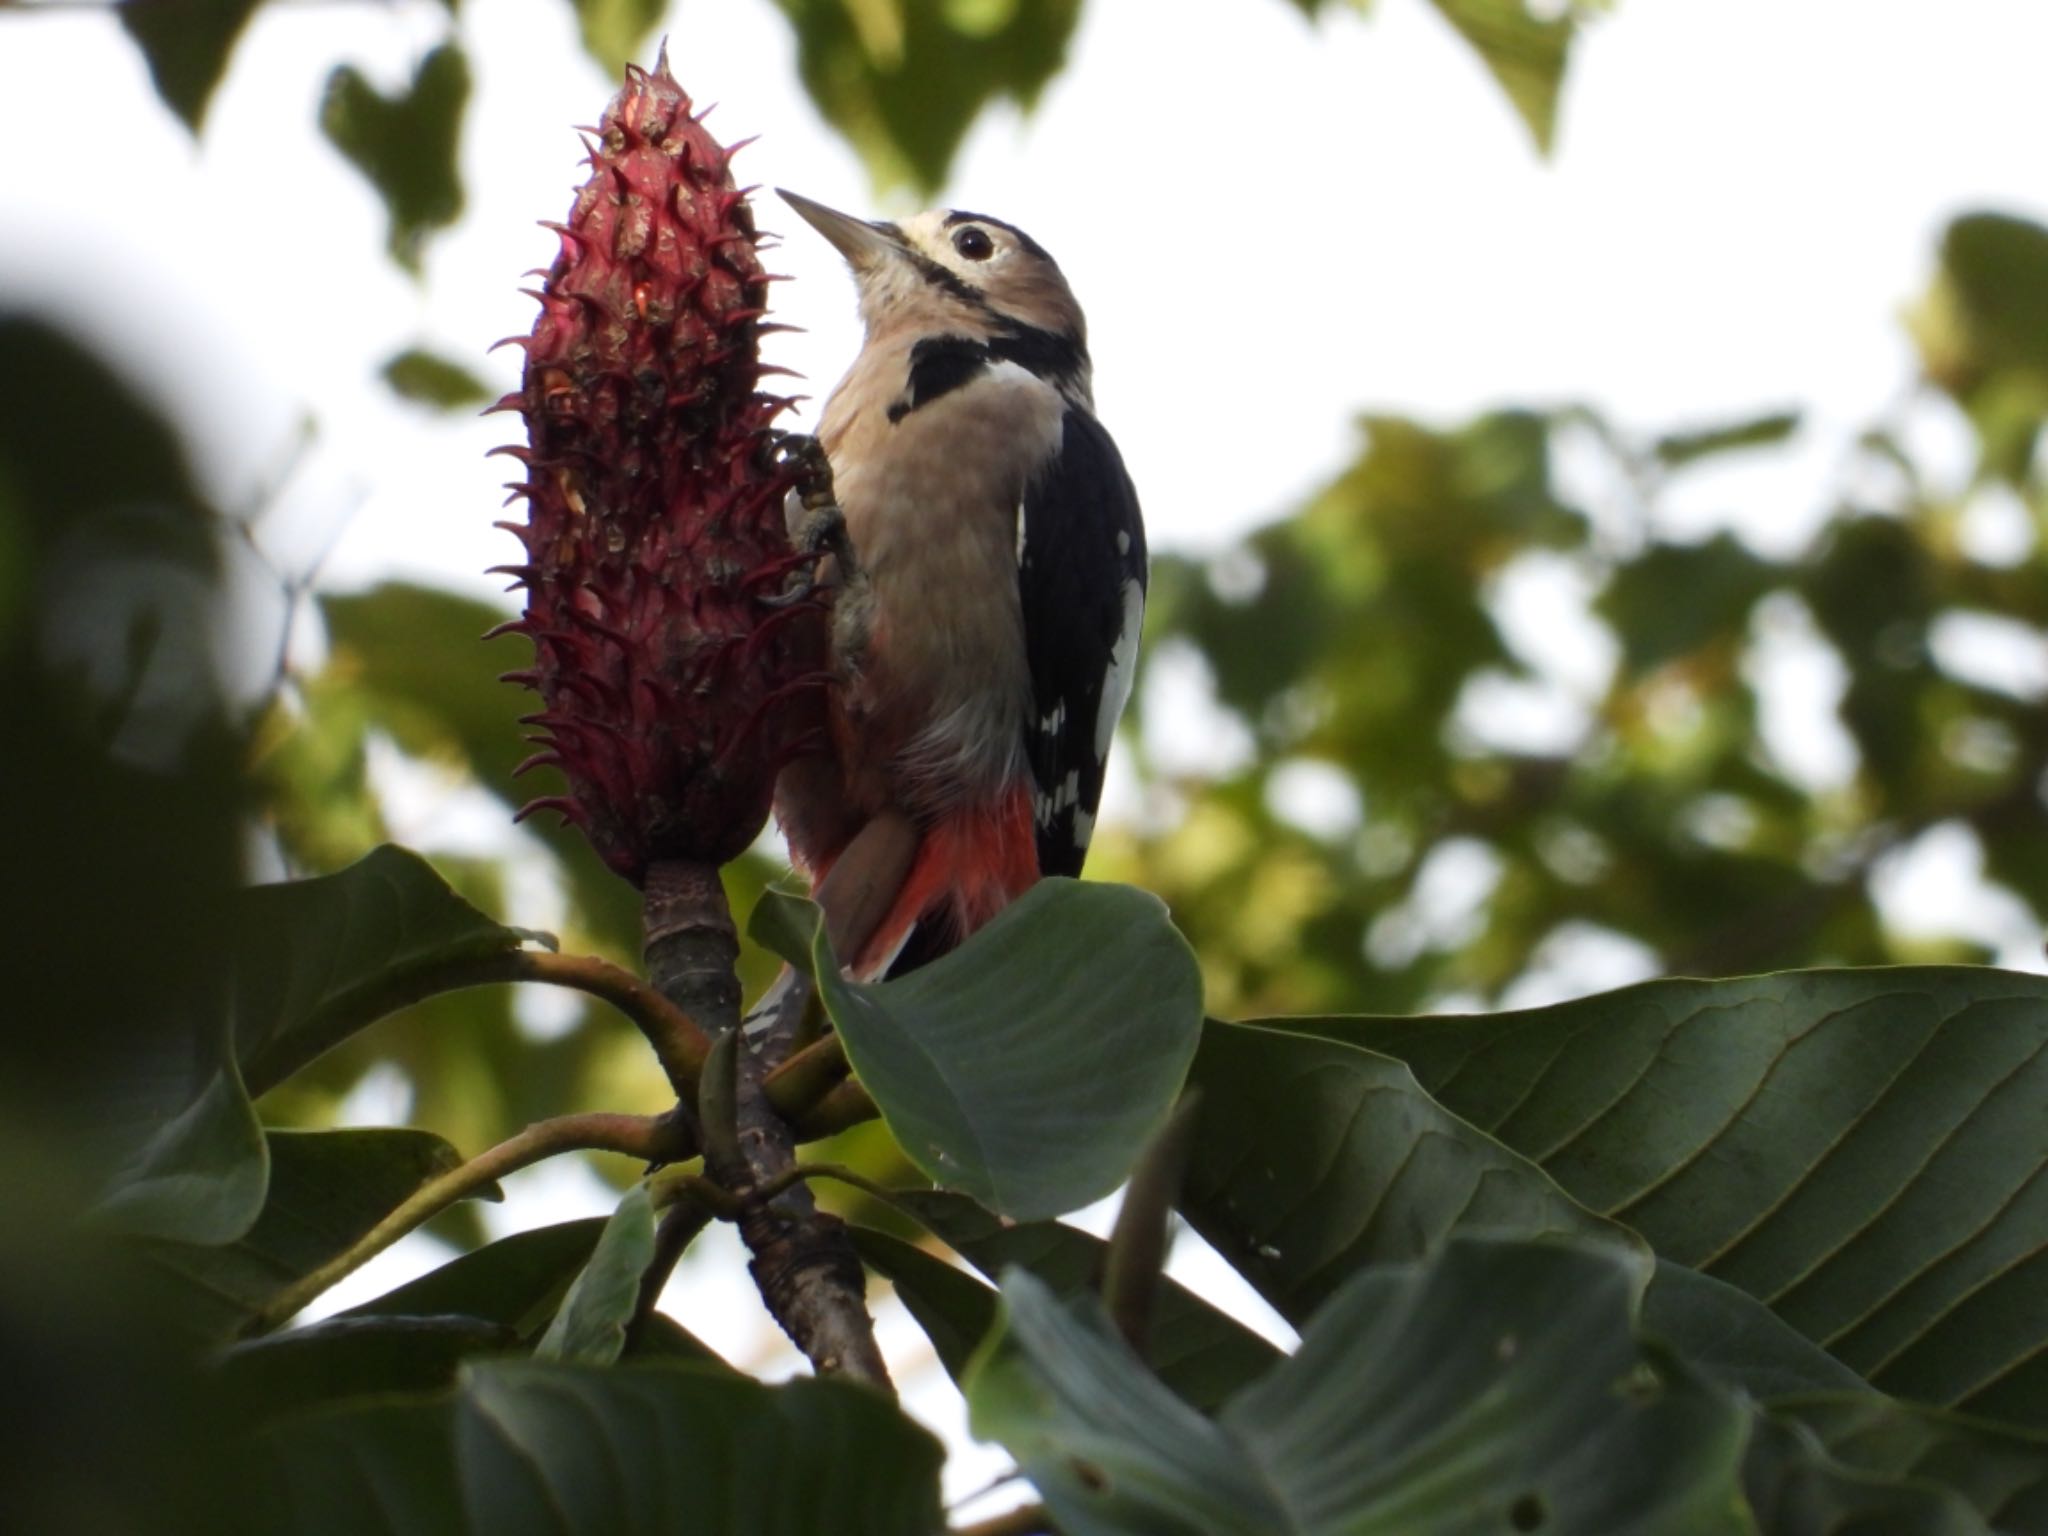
[{"x1": 219, "y1": 1317, "x2": 518, "y2": 1423}]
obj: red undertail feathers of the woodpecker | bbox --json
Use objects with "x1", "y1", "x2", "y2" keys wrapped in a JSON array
[{"x1": 852, "y1": 786, "x2": 1038, "y2": 981}]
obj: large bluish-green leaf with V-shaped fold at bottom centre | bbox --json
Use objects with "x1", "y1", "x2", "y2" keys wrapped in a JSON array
[{"x1": 967, "y1": 1237, "x2": 1751, "y2": 1536}]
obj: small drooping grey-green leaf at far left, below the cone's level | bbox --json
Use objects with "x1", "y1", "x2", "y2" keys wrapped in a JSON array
[{"x1": 92, "y1": 1061, "x2": 270, "y2": 1243}]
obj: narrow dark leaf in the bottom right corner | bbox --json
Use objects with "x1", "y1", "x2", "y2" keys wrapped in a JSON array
[{"x1": 1769, "y1": 1393, "x2": 2048, "y2": 1532}]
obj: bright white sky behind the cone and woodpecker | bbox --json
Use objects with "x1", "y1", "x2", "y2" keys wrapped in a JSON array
[{"x1": 0, "y1": 0, "x2": 2048, "y2": 1515}]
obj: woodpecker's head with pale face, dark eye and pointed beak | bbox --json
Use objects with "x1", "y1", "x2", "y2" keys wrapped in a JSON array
[{"x1": 780, "y1": 193, "x2": 1087, "y2": 356}]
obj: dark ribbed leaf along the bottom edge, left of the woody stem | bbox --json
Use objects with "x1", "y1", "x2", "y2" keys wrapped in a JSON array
[{"x1": 260, "y1": 1362, "x2": 944, "y2": 1536}]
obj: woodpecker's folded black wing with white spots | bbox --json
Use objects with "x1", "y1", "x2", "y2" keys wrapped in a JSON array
[{"x1": 1018, "y1": 406, "x2": 1147, "y2": 874}]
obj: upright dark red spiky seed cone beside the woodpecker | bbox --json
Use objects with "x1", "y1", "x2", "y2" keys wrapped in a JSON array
[{"x1": 502, "y1": 53, "x2": 821, "y2": 883}]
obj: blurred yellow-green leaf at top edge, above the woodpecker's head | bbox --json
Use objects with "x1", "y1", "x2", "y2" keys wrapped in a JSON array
[{"x1": 776, "y1": 0, "x2": 1081, "y2": 193}]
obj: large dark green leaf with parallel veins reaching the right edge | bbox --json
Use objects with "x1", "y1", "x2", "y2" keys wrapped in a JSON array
[{"x1": 1290, "y1": 967, "x2": 2048, "y2": 1423}]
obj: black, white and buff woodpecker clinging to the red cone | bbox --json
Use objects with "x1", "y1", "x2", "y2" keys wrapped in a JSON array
[{"x1": 776, "y1": 193, "x2": 1147, "y2": 977}]
